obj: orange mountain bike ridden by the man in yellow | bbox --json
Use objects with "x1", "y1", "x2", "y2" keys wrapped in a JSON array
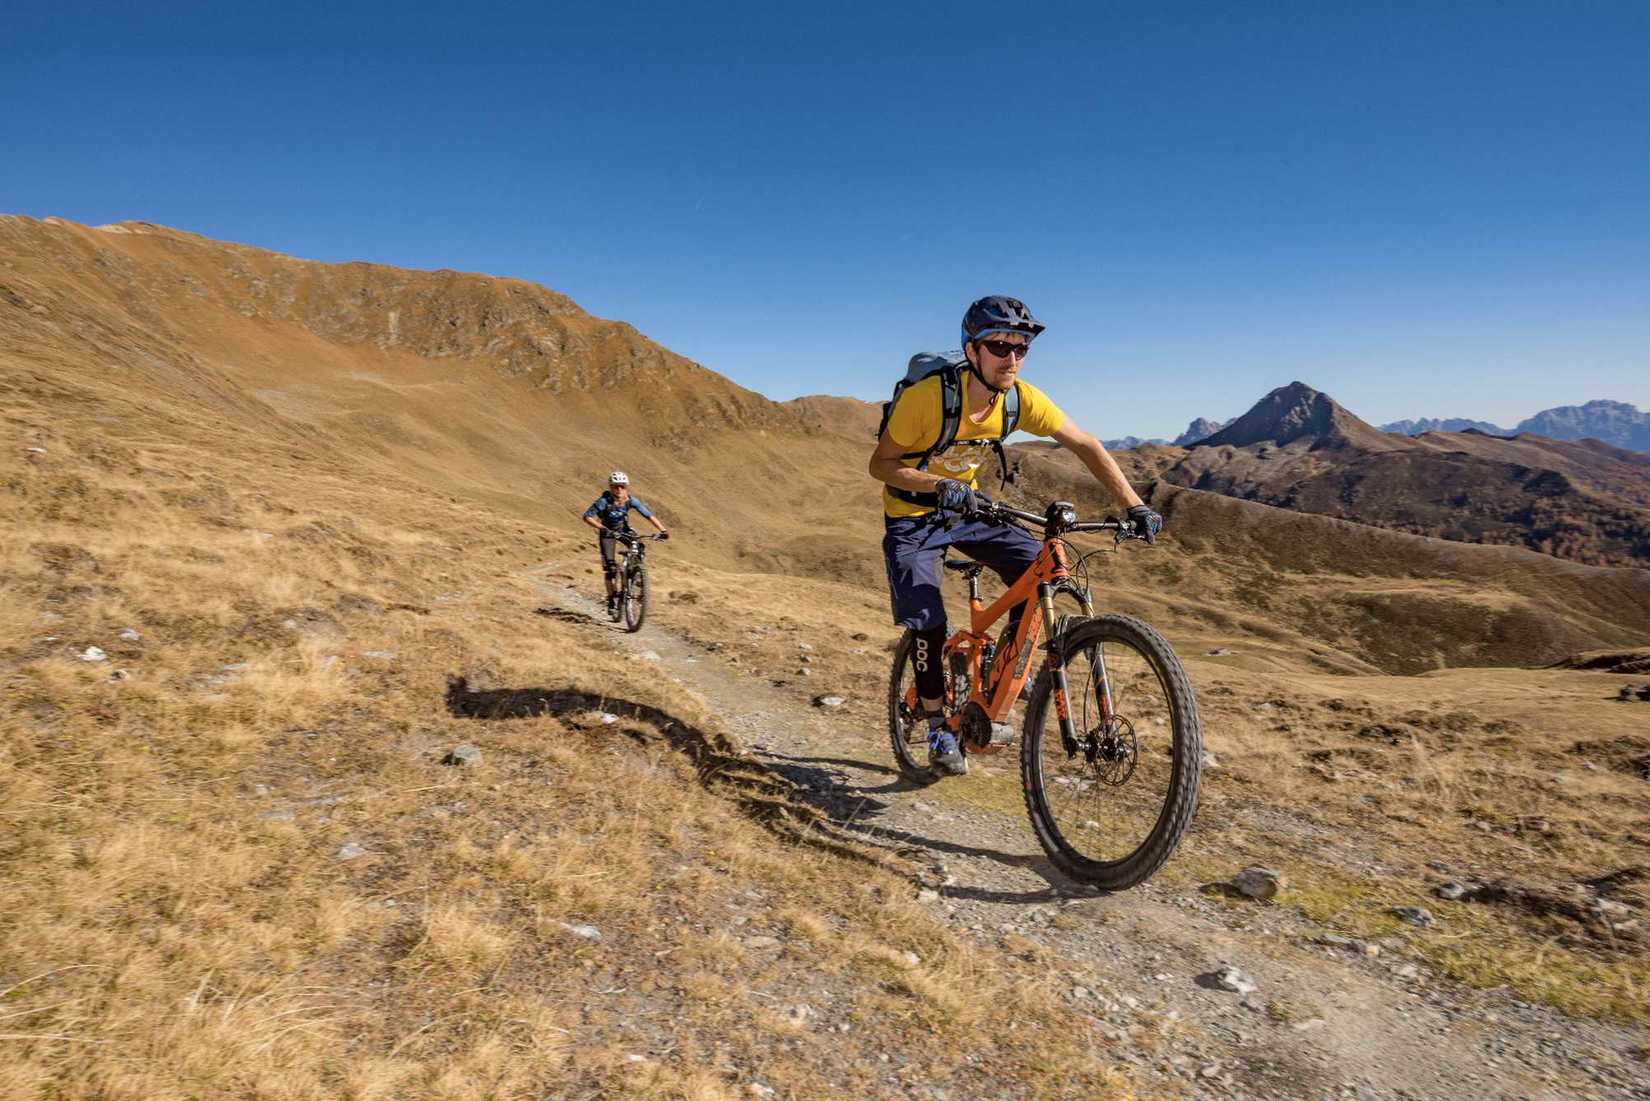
[{"x1": 888, "y1": 502, "x2": 1203, "y2": 891}]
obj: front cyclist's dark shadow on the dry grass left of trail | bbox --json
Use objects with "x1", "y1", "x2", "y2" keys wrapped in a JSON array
[{"x1": 447, "y1": 677, "x2": 886, "y2": 867}]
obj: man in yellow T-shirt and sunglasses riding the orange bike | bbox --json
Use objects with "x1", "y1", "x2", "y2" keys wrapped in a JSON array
[{"x1": 870, "y1": 295, "x2": 1163, "y2": 776}]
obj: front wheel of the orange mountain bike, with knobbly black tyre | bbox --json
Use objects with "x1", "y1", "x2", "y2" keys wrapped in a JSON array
[{"x1": 1020, "y1": 616, "x2": 1203, "y2": 891}]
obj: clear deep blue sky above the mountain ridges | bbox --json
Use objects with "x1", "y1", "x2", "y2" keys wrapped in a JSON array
[{"x1": 0, "y1": 0, "x2": 1650, "y2": 436}]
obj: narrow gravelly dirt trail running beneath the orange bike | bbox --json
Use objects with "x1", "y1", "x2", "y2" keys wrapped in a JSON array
[{"x1": 543, "y1": 583, "x2": 1650, "y2": 1101}]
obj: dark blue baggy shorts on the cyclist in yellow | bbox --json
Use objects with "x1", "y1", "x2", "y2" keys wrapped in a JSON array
[{"x1": 883, "y1": 513, "x2": 1043, "y2": 631}]
